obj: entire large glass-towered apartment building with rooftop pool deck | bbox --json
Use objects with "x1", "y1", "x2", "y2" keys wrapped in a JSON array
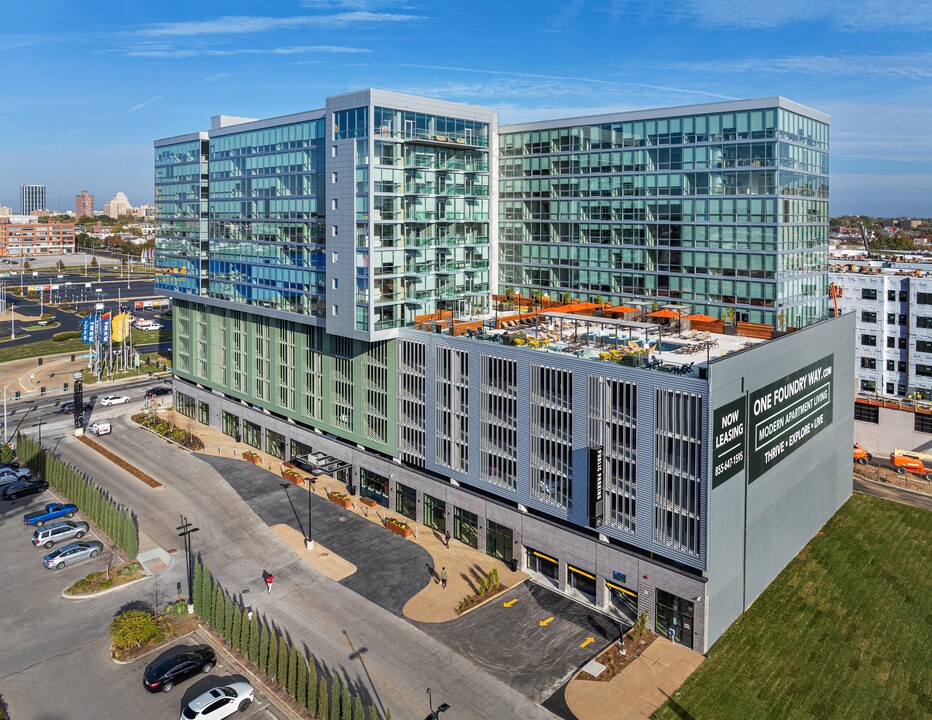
[{"x1": 155, "y1": 90, "x2": 854, "y2": 651}]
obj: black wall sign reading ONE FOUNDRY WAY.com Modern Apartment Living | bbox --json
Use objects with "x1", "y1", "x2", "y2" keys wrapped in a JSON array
[{"x1": 748, "y1": 355, "x2": 834, "y2": 484}]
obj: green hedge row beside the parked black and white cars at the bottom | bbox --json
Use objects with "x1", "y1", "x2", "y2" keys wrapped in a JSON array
[{"x1": 192, "y1": 562, "x2": 392, "y2": 720}]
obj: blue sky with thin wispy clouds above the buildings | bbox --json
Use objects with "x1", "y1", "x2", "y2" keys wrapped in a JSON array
[{"x1": 0, "y1": 0, "x2": 932, "y2": 216}]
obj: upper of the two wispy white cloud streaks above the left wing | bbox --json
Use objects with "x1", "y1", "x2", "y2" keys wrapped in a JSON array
[{"x1": 138, "y1": 11, "x2": 423, "y2": 37}]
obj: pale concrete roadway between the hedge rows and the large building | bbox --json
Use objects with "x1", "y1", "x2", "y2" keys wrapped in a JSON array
[{"x1": 10, "y1": 410, "x2": 553, "y2": 720}]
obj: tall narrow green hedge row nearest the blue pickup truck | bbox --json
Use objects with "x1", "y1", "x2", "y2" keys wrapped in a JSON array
[{"x1": 16, "y1": 432, "x2": 139, "y2": 560}]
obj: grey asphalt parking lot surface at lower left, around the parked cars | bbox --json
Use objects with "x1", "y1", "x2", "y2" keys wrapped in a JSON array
[{"x1": 0, "y1": 484, "x2": 275, "y2": 720}]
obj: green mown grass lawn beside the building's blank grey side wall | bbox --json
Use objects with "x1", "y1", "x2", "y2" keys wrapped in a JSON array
[{"x1": 655, "y1": 495, "x2": 932, "y2": 720}]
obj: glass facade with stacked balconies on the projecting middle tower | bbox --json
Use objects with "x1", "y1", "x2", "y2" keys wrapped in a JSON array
[{"x1": 366, "y1": 106, "x2": 490, "y2": 331}]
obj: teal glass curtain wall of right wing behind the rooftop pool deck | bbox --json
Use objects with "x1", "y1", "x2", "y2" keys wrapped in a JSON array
[{"x1": 499, "y1": 99, "x2": 828, "y2": 329}]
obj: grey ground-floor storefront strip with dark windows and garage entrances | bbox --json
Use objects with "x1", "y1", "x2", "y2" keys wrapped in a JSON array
[{"x1": 175, "y1": 381, "x2": 706, "y2": 652}]
